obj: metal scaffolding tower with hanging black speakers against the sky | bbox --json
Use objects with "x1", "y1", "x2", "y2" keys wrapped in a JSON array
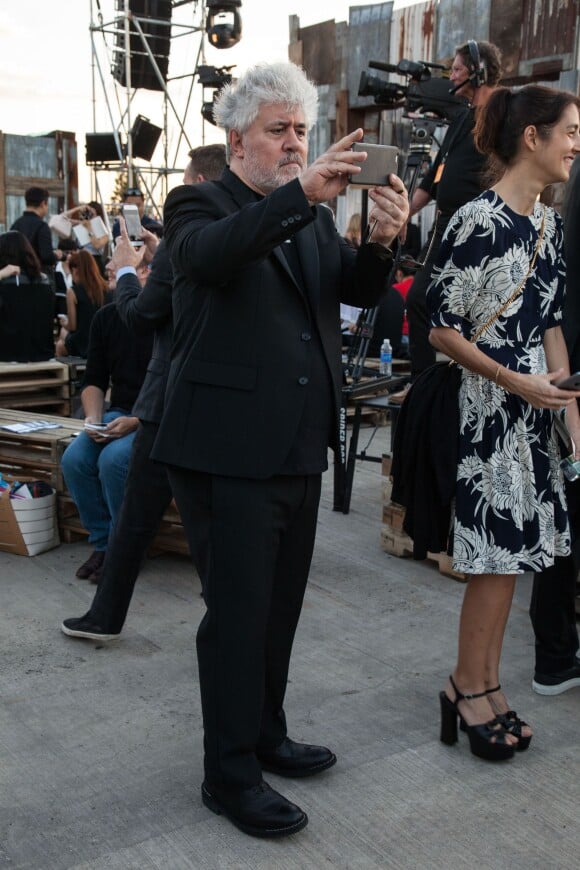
[{"x1": 86, "y1": 0, "x2": 213, "y2": 212}]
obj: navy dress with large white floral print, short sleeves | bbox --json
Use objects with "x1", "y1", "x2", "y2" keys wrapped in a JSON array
[{"x1": 427, "y1": 190, "x2": 570, "y2": 574}]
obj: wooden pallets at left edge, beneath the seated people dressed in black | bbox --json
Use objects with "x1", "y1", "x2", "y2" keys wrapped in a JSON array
[{"x1": 0, "y1": 360, "x2": 70, "y2": 415}]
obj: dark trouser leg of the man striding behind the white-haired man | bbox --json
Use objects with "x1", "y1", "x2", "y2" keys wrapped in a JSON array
[{"x1": 89, "y1": 421, "x2": 172, "y2": 633}]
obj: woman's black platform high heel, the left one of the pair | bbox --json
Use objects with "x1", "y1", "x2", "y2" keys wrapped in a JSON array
[{"x1": 439, "y1": 676, "x2": 515, "y2": 761}]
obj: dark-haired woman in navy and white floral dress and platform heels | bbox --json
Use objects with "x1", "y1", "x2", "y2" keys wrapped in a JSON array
[{"x1": 428, "y1": 85, "x2": 580, "y2": 760}]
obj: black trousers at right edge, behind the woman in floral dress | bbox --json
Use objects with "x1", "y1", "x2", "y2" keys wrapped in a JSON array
[{"x1": 530, "y1": 480, "x2": 580, "y2": 674}]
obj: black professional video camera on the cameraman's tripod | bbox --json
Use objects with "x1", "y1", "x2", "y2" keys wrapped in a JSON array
[{"x1": 358, "y1": 59, "x2": 467, "y2": 121}]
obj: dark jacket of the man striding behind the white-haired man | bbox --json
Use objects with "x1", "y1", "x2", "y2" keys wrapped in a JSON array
[{"x1": 115, "y1": 240, "x2": 173, "y2": 423}]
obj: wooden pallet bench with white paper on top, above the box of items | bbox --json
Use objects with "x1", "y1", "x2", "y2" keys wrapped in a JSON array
[{"x1": 0, "y1": 408, "x2": 83, "y2": 493}]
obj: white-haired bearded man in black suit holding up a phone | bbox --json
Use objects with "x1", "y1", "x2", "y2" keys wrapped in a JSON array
[{"x1": 152, "y1": 63, "x2": 408, "y2": 836}]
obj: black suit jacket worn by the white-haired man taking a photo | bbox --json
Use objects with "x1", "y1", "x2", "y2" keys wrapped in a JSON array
[{"x1": 152, "y1": 169, "x2": 391, "y2": 478}]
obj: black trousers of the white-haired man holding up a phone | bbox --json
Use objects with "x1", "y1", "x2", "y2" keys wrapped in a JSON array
[{"x1": 168, "y1": 466, "x2": 320, "y2": 788}]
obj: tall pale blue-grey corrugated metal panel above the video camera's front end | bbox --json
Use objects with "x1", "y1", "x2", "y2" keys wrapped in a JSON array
[{"x1": 347, "y1": 2, "x2": 393, "y2": 108}]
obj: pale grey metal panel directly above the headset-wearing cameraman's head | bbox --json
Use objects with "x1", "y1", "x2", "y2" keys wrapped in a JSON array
[{"x1": 434, "y1": 0, "x2": 490, "y2": 61}]
